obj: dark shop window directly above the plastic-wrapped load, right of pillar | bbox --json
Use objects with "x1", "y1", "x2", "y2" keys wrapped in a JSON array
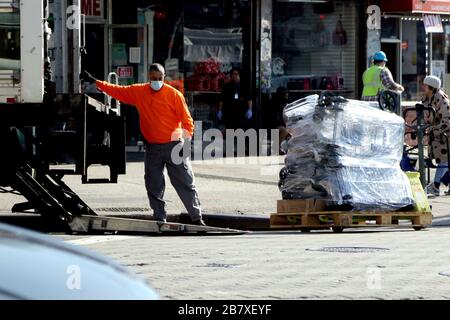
[{"x1": 271, "y1": 0, "x2": 358, "y2": 100}]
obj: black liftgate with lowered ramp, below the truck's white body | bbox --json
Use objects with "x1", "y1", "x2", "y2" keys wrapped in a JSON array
[{"x1": 0, "y1": 94, "x2": 243, "y2": 234}]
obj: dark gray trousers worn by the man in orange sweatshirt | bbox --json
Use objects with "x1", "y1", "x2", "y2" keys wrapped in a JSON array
[{"x1": 144, "y1": 141, "x2": 202, "y2": 221}]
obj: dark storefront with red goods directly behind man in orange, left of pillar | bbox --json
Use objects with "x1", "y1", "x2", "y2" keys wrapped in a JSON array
[{"x1": 80, "y1": 0, "x2": 255, "y2": 144}]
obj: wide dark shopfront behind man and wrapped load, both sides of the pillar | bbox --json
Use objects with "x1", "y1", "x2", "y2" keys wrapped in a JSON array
[{"x1": 81, "y1": 0, "x2": 364, "y2": 143}]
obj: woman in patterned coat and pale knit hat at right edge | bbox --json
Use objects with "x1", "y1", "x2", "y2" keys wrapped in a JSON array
[{"x1": 422, "y1": 76, "x2": 450, "y2": 196}]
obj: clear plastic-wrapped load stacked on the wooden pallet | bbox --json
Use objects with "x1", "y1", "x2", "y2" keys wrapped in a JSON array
[{"x1": 279, "y1": 95, "x2": 414, "y2": 210}]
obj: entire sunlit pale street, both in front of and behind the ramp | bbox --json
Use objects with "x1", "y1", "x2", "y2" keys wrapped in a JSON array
[{"x1": 0, "y1": 157, "x2": 450, "y2": 299}]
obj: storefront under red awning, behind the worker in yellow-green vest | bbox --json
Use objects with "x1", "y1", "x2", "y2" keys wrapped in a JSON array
[{"x1": 380, "y1": 0, "x2": 450, "y2": 101}]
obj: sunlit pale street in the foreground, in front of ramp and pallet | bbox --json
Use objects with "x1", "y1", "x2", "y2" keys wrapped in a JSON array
[{"x1": 60, "y1": 228, "x2": 450, "y2": 300}]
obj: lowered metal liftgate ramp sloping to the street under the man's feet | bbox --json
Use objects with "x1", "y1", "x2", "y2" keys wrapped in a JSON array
[{"x1": 12, "y1": 166, "x2": 243, "y2": 235}]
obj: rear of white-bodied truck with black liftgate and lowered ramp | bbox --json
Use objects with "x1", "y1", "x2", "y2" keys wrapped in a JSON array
[{"x1": 0, "y1": 0, "x2": 243, "y2": 234}]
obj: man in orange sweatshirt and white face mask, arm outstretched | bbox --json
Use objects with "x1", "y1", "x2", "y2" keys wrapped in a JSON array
[{"x1": 83, "y1": 63, "x2": 205, "y2": 225}]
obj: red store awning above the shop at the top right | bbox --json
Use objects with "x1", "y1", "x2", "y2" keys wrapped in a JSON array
[{"x1": 381, "y1": 0, "x2": 450, "y2": 14}]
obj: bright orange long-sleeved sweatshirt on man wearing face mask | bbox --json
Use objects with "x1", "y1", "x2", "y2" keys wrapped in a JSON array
[{"x1": 95, "y1": 80, "x2": 194, "y2": 143}]
